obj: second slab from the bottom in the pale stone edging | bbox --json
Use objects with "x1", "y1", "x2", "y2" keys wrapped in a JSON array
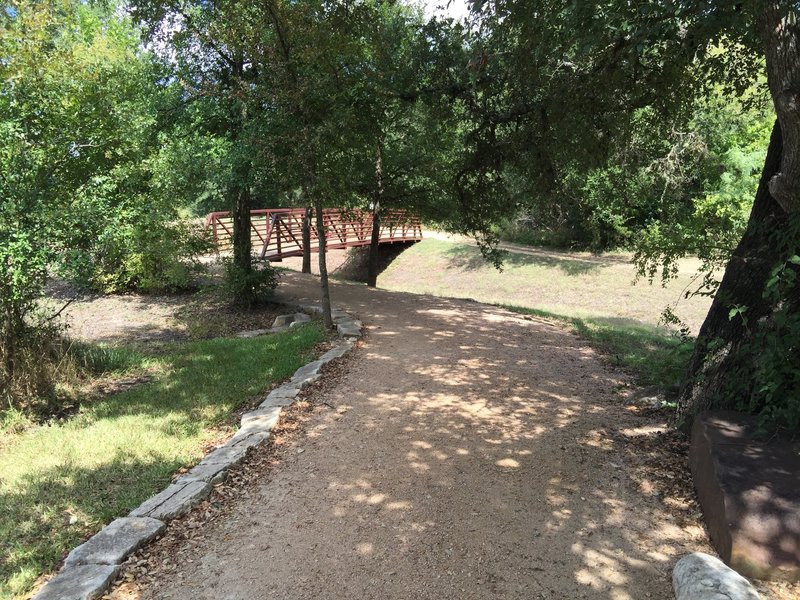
[{"x1": 65, "y1": 517, "x2": 166, "y2": 565}]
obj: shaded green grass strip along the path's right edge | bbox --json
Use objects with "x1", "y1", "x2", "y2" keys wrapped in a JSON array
[{"x1": 503, "y1": 305, "x2": 694, "y2": 388}]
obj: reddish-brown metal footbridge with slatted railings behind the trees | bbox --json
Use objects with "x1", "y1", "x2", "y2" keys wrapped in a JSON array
[{"x1": 206, "y1": 208, "x2": 422, "y2": 262}]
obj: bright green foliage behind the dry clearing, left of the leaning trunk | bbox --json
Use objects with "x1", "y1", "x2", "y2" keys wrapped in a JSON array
[{"x1": 501, "y1": 93, "x2": 773, "y2": 256}]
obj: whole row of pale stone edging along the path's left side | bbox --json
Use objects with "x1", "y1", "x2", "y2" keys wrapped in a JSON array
[{"x1": 33, "y1": 303, "x2": 361, "y2": 600}]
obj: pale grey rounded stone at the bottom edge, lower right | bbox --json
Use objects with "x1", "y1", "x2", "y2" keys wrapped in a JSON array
[{"x1": 672, "y1": 552, "x2": 759, "y2": 600}]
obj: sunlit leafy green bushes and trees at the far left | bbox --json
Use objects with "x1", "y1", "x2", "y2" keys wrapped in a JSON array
[{"x1": 0, "y1": 2, "x2": 208, "y2": 402}]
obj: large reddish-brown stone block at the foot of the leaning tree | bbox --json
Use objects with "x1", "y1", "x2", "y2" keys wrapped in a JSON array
[{"x1": 689, "y1": 411, "x2": 800, "y2": 581}]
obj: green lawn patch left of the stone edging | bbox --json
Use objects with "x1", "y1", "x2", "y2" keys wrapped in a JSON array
[{"x1": 0, "y1": 324, "x2": 325, "y2": 598}]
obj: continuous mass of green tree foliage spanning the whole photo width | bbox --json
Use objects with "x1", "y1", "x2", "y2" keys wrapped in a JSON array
[{"x1": 0, "y1": 0, "x2": 800, "y2": 426}]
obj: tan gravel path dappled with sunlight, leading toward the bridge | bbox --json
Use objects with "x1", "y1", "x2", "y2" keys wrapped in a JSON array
[{"x1": 122, "y1": 274, "x2": 702, "y2": 600}]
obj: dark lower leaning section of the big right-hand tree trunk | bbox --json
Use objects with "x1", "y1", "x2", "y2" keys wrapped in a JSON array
[{"x1": 678, "y1": 122, "x2": 789, "y2": 428}]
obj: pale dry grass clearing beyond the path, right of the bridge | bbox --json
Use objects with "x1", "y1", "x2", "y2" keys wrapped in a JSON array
[{"x1": 378, "y1": 238, "x2": 710, "y2": 333}]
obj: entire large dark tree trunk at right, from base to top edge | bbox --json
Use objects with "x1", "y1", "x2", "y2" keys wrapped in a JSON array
[{"x1": 678, "y1": 0, "x2": 800, "y2": 427}]
